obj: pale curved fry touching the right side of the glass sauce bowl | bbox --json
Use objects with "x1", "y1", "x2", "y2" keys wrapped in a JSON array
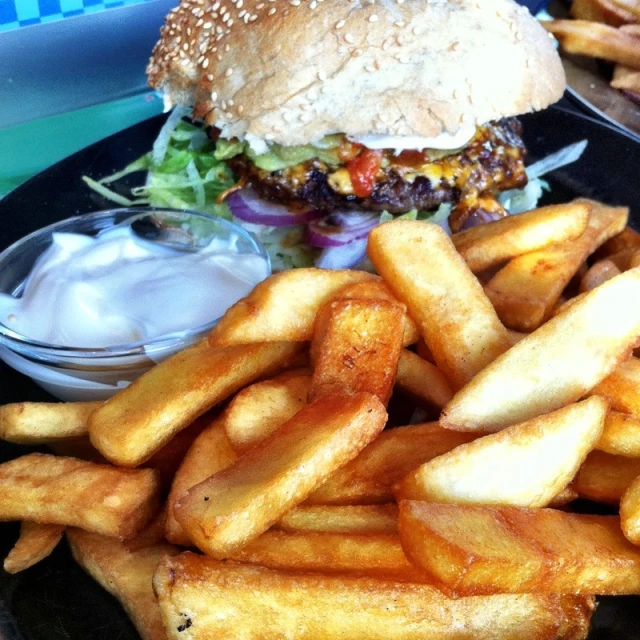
[{"x1": 209, "y1": 268, "x2": 375, "y2": 347}]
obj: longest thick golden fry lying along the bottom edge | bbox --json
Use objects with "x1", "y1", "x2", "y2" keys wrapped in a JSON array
[{"x1": 154, "y1": 553, "x2": 594, "y2": 640}]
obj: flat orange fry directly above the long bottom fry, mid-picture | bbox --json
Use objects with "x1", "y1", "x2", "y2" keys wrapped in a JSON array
[{"x1": 230, "y1": 531, "x2": 433, "y2": 584}]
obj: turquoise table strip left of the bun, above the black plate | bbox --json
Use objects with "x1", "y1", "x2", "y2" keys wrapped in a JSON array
[{"x1": 0, "y1": 91, "x2": 163, "y2": 197}]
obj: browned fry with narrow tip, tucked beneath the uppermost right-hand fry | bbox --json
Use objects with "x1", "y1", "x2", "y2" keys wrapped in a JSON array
[{"x1": 485, "y1": 200, "x2": 629, "y2": 332}]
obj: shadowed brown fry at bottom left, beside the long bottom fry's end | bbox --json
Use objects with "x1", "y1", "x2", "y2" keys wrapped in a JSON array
[{"x1": 67, "y1": 529, "x2": 180, "y2": 640}]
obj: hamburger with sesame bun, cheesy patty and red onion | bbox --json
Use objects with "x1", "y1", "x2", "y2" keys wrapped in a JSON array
[{"x1": 147, "y1": 0, "x2": 565, "y2": 266}]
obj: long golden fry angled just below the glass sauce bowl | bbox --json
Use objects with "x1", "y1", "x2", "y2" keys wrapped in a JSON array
[{"x1": 89, "y1": 342, "x2": 301, "y2": 467}]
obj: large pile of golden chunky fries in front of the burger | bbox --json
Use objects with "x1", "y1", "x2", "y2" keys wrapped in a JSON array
[{"x1": 0, "y1": 200, "x2": 640, "y2": 640}]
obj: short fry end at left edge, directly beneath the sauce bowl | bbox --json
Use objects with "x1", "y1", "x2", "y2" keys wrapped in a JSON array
[{"x1": 0, "y1": 402, "x2": 102, "y2": 445}]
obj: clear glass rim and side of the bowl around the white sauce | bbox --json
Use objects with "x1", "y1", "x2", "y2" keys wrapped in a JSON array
[{"x1": 0, "y1": 206, "x2": 272, "y2": 363}]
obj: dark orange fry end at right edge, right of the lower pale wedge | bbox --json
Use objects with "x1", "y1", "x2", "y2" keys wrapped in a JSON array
[{"x1": 572, "y1": 451, "x2": 640, "y2": 505}]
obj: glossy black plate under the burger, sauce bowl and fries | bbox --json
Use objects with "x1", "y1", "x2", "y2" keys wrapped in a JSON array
[{"x1": 0, "y1": 102, "x2": 640, "y2": 640}]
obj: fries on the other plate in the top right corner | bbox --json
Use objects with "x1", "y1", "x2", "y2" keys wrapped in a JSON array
[{"x1": 542, "y1": 0, "x2": 640, "y2": 102}]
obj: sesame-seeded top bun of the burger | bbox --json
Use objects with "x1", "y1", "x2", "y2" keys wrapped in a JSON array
[{"x1": 147, "y1": 0, "x2": 565, "y2": 145}]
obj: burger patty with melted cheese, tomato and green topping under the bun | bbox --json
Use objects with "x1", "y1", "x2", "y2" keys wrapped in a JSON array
[{"x1": 215, "y1": 118, "x2": 527, "y2": 231}]
